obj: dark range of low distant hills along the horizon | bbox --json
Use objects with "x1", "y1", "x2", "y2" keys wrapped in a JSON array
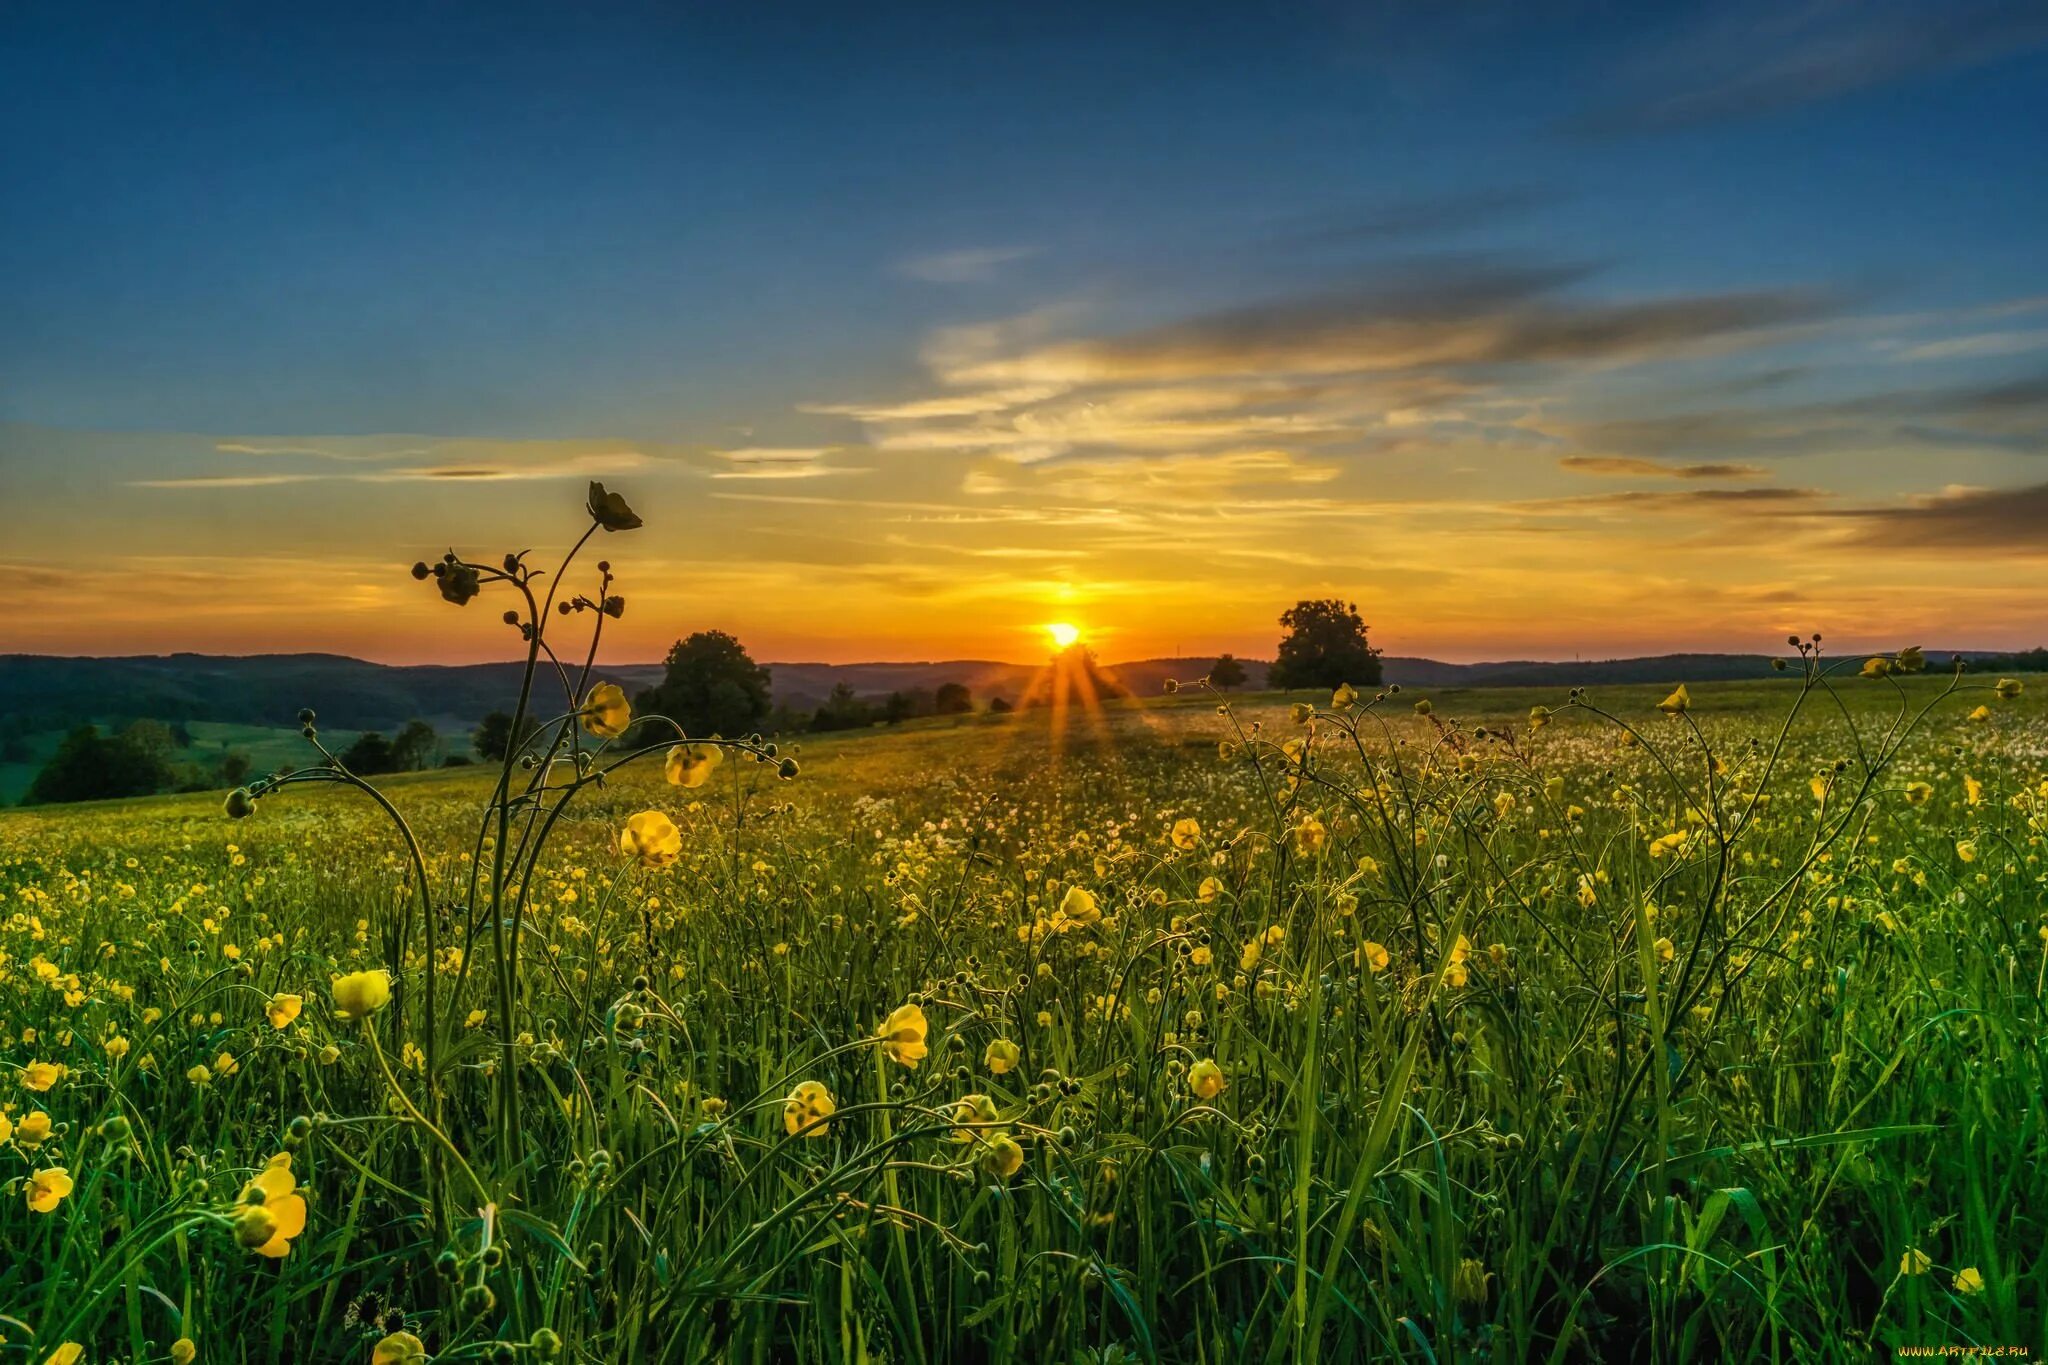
[{"x1": 0, "y1": 649, "x2": 2031, "y2": 731}]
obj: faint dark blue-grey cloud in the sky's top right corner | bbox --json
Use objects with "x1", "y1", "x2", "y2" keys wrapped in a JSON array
[{"x1": 1575, "y1": 0, "x2": 2048, "y2": 135}]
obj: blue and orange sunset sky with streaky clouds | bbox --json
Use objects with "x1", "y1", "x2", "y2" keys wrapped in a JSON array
[{"x1": 0, "y1": 0, "x2": 2048, "y2": 661}]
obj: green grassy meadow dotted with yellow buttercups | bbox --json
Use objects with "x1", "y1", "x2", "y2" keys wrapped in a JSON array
[{"x1": 0, "y1": 655, "x2": 2048, "y2": 1363}]
